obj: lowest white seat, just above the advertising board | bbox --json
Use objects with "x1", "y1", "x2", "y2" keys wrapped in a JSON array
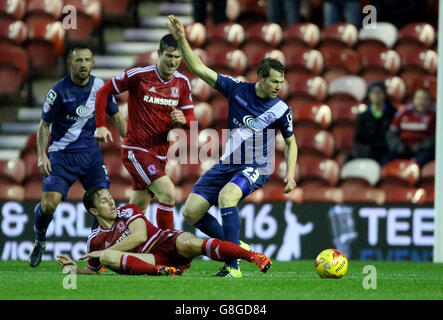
[{"x1": 340, "y1": 159, "x2": 381, "y2": 186}]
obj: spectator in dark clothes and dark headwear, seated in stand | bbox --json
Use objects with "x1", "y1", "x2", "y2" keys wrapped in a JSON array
[{"x1": 351, "y1": 81, "x2": 397, "y2": 162}]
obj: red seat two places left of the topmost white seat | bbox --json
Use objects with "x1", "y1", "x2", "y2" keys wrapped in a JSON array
[{"x1": 283, "y1": 22, "x2": 320, "y2": 48}]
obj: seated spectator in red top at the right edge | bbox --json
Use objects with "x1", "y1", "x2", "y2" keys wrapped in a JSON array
[{"x1": 382, "y1": 89, "x2": 435, "y2": 166}]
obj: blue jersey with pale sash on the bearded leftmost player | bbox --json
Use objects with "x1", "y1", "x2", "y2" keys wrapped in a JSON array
[{"x1": 42, "y1": 74, "x2": 118, "y2": 152}]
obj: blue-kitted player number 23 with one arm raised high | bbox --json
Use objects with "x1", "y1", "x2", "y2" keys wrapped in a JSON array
[{"x1": 168, "y1": 16, "x2": 298, "y2": 277}]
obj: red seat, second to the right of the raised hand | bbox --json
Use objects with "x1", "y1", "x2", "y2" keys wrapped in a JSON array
[{"x1": 208, "y1": 22, "x2": 245, "y2": 48}]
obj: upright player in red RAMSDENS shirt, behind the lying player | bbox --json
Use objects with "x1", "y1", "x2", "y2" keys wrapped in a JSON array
[{"x1": 95, "y1": 34, "x2": 195, "y2": 229}]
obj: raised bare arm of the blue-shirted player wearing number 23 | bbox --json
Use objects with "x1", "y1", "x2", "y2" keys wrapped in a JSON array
[{"x1": 167, "y1": 15, "x2": 217, "y2": 87}]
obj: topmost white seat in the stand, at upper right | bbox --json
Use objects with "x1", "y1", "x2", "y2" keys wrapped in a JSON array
[{"x1": 357, "y1": 22, "x2": 398, "y2": 54}]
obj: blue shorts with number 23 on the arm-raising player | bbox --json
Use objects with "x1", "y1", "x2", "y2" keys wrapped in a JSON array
[{"x1": 191, "y1": 163, "x2": 269, "y2": 205}]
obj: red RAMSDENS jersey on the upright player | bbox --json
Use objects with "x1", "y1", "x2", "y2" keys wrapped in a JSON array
[{"x1": 112, "y1": 64, "x2": 194, "y2": 157}]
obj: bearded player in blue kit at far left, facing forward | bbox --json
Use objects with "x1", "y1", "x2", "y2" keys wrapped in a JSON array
[{"x1": 29, "y1": 44, "x2": 126, "y2": 267}]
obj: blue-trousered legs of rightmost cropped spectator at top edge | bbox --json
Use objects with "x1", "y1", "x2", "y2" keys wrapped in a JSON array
[{"x1": 323, "y1": 0, "x2": 361, "y2": 29}]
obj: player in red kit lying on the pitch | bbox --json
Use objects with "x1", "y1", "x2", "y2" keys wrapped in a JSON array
[{"x1": 58, "y1": 187, "x2": 272, "y2": 275}]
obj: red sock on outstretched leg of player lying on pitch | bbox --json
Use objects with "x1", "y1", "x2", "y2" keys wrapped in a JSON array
[{"x1": 201, "y1": 238, "x2": 254, "y2": 262}]
